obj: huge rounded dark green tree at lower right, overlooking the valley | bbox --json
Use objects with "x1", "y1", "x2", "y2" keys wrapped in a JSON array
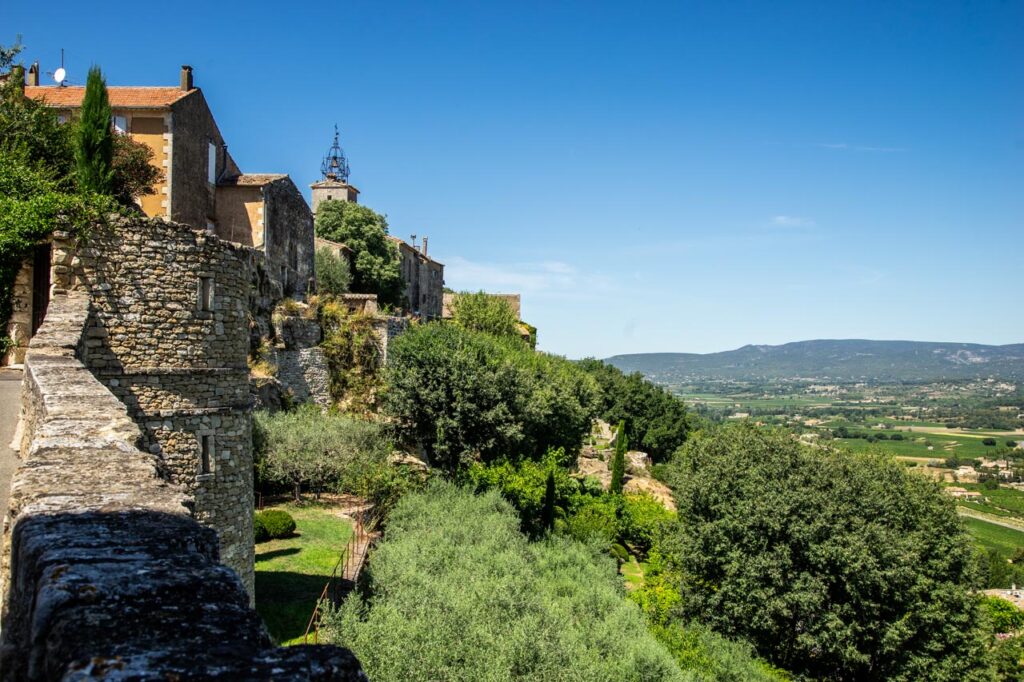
[{"x1": 666, "y1": 424, "x2": 988, "y2": 680}]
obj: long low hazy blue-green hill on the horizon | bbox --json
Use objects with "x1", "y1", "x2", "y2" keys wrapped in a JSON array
[{"x1": 605, "y1": 339, "x2": 1024, "y2": 384}]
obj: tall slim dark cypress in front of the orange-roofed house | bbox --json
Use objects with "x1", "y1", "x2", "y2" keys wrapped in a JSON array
[{"x1": 75, "y1": 67, "x2": 114, "y2": 195}]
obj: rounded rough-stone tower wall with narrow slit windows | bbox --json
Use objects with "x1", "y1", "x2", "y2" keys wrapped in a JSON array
[{"x1": 53, "y1": 218, "x2": 260, "y2": 594}]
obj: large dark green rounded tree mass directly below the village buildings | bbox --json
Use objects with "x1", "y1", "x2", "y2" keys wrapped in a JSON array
[{"x1": 384, "y1": 324, "x2": 596, "y2": 473}]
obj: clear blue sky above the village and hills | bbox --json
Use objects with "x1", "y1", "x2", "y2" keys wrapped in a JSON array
[{"x1": 0, "y1": 0, "x2": 1024, "y2": 357}]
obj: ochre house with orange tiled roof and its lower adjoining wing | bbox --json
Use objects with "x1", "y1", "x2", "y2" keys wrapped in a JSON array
[{"x1": 25, "y1": 66, "x2": 313, "y2": 297}]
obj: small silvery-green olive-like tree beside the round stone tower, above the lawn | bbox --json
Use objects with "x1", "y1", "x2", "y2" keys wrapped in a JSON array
[{"x1": 254, "y1": 404, "x2": 389, "y2": 502}]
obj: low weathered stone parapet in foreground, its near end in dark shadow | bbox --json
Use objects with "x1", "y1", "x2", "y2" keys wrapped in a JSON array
[{"x1": 0, "y1": 291, "x2": 367, "y2": 681}]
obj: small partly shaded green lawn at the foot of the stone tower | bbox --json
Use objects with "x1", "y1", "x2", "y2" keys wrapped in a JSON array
[{"x1": 256, "y1": 503, "x2": 352, "y2": 644}]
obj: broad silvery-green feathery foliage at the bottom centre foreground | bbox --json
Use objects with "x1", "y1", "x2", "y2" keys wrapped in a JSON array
[{"x1": 322, "y1": 483, "x2": 686, "y2": 682}]
